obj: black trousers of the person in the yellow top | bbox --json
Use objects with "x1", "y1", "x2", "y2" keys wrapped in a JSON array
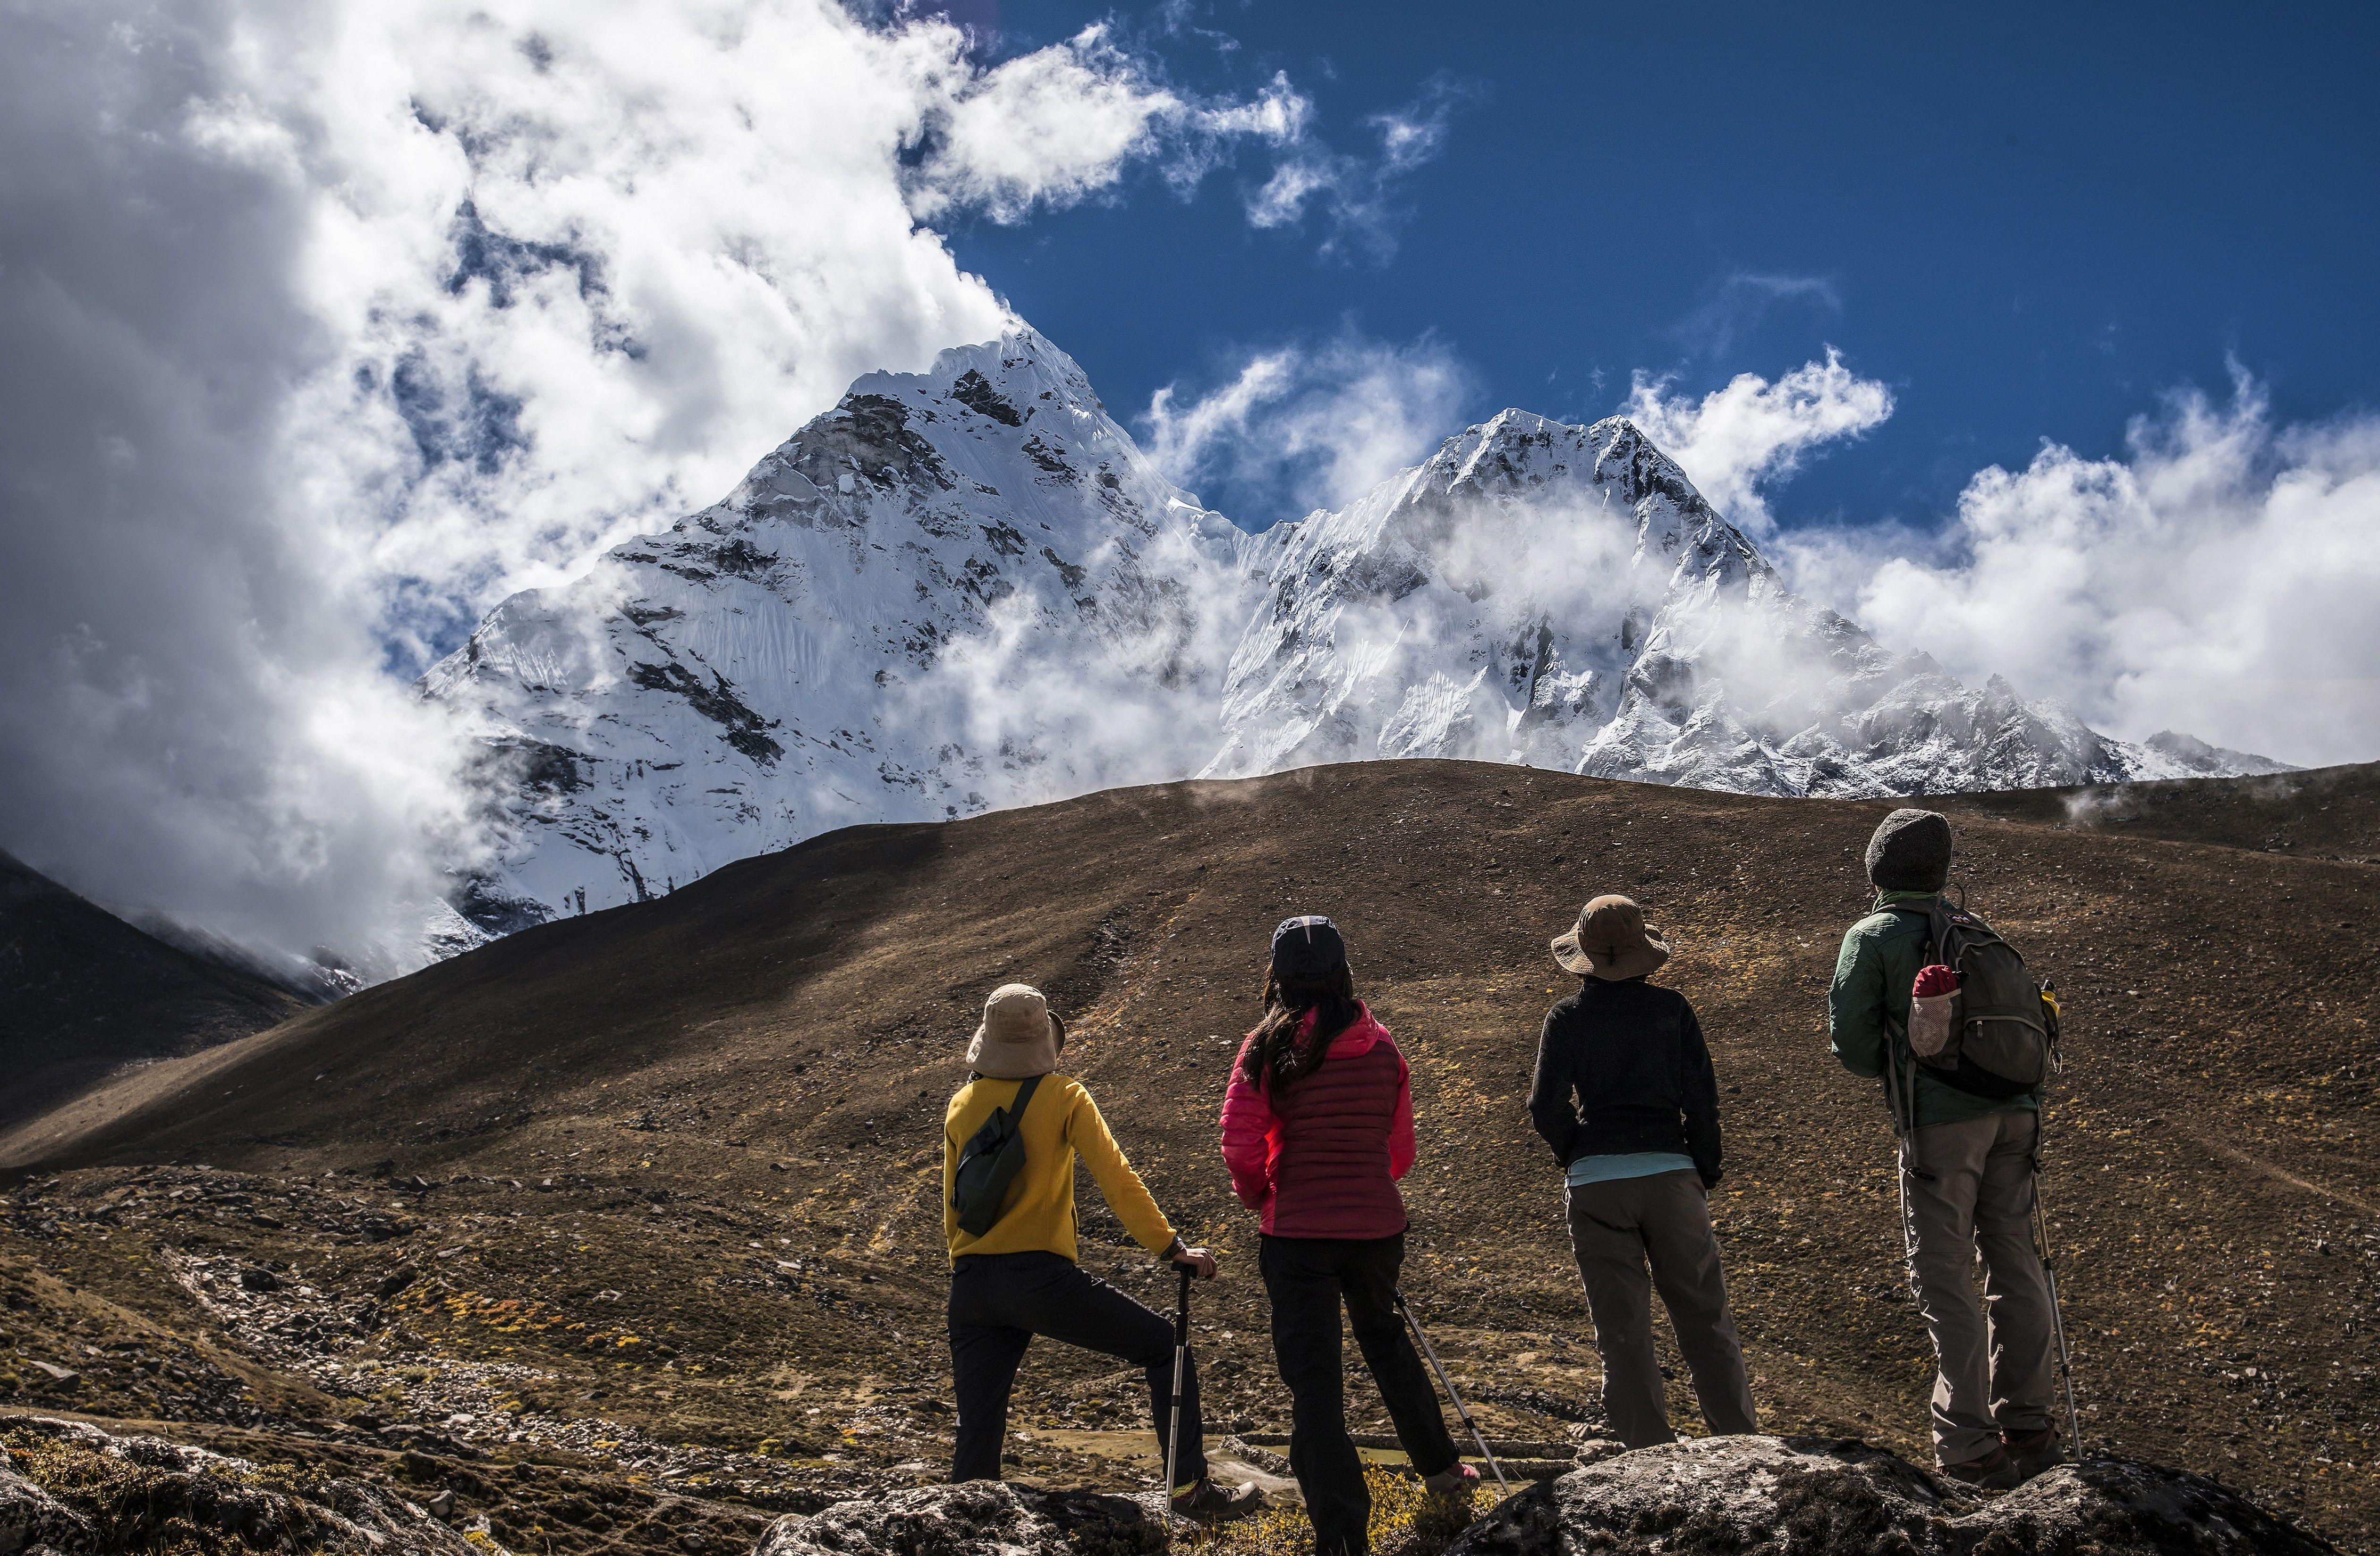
[{"x1": 950, "y1": 1254, "x2": 1207, "y2": 1485}]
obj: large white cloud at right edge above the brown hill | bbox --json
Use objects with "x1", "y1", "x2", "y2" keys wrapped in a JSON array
[{"x1": 1785, "y1": 376, "x2": 2380, "y2": 764}]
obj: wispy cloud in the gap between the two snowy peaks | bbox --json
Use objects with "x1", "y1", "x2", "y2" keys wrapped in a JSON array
[{"x1": 1140, "y1": 328, "x2": 1473, "y2": 524}]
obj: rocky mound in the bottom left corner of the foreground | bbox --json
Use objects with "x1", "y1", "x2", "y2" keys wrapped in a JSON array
[{"x1": 0, "y1": 1416, "x2": 502, "y2": 1556}]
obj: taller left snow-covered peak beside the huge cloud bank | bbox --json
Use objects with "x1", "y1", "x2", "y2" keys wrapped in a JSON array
[{"x1": 421, "y1": 328, "x2": 1254, "y2": 930}]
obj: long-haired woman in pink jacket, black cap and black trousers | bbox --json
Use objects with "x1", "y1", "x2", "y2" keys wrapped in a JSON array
[{"x1": 1224, "y1": 916, "x2": 1478, "y2": 1556}]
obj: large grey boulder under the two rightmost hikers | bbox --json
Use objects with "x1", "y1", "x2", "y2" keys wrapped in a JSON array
[{"x1": 1447, "y1": 1437, "x2": 2337, "y2": 1556}]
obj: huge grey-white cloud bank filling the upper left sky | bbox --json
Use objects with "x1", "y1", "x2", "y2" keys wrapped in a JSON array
[{"x1": 0, "y1": 0, "x2": 1361, "y2": 971}]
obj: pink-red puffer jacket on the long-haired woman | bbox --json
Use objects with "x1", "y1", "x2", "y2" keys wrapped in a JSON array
[{"x1": 1224, "y1": 1009, "x2": 1414, "y2": 1237}]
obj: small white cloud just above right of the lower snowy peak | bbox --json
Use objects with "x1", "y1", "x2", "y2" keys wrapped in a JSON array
[{"x1": 1621, "y1": 347, "x2": 1892, "y2": 535}]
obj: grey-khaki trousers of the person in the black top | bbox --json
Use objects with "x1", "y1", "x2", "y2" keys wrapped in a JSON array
[{"x1": 1571, "y1": 1171, "x2": 1759, "y2": 1449}]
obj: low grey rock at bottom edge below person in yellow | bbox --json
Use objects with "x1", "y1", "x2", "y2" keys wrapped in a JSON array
[{"x1": 752, "y1": 1480, "x2": 1166, "y2": 1556}]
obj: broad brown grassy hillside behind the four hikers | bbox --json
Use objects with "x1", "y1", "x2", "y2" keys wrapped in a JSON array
[{"x1": 0, "y1": 761, "x2": 2380, "y2": 1549}]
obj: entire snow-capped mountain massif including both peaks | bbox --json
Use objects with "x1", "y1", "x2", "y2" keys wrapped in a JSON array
[{"x1": 421, "y1": 328, "x2": 2278, "y2": 933}]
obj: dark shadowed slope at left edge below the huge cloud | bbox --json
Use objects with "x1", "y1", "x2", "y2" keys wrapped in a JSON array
[{"x1": 0, "y1": 852, "x2": 307, "y2": 1125}]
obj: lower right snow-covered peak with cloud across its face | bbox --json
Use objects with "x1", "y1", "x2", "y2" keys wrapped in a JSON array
[{"x1": 1207, "y1": 412, "x2": 2227, "y2": 797}]
